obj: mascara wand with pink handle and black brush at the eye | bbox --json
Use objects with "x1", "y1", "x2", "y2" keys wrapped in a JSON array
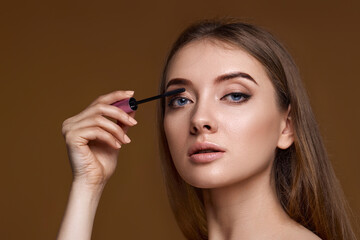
[{"x1": 111, "y1": 88, "x2": 185, "y2": 113}]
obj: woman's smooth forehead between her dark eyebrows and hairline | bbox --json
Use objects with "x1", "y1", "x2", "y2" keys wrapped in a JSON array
[{"x1": 166, "y1": 39, "x2": 267, "y2": 83}]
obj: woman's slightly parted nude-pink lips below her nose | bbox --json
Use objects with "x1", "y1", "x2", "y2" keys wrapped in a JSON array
[{"x1": 188, "y1": 142, "x2": 225, "y2": 163}]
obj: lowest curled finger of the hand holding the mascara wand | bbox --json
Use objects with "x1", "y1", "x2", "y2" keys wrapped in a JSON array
[{"x1": 66, "y1": 127, "x2": 121, "y2": 149}]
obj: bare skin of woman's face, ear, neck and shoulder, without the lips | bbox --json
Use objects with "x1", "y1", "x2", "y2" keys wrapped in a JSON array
[{"x1": 164, "y1": 39, "x2": 319, "y2": 240}]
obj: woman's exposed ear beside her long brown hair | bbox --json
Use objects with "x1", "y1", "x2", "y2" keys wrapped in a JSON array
[{"x1": 277, "y1": 105, "x2": 294, "y2": 149}]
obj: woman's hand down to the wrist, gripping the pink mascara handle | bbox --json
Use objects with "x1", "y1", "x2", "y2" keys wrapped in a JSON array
[{"x1": 62, "y1": 91, "x2": 137, "y2": 189}]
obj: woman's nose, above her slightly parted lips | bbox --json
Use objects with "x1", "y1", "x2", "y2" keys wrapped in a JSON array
[{"x1": 190, "y1": 101, "x2": 218, "y2": 135}]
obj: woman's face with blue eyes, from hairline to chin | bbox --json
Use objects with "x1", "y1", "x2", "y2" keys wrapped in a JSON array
[{"x1": 164, "y1": 40, "x2": 292, "y2": 188}]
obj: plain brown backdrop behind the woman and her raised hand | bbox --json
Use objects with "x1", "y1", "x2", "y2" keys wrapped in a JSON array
[{"x1": 0, "y1": 0, "x2": 360, "y2": 239}]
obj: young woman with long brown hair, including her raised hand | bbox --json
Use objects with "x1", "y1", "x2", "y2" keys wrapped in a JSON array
[{"x1": 58, "y1": 21, "x2": 356, "y2": 240}]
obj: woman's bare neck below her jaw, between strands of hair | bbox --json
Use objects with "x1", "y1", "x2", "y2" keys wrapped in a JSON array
[{"x1": 203, "y1": 170, "x2": 290, "y2": 240}]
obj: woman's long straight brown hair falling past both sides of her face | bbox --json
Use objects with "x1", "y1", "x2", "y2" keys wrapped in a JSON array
[{"x1": 158, "y1": 20, "x2": 356, "y2": 240}]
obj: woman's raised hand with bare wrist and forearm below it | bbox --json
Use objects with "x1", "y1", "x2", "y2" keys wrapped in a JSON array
[{"x1": 57, "y1": 91, "x2": 137, "y2": 240}]
